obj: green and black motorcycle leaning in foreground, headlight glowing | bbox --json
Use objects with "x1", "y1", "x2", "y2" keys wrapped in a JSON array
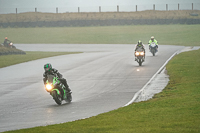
[{"x1": 45, "y1": 75, "x2": 72, "y2": 105}]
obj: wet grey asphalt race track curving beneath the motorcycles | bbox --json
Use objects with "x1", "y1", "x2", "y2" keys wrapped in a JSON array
[{"x1": 0, "y1": 44, "x2": 184, "y2": 132}]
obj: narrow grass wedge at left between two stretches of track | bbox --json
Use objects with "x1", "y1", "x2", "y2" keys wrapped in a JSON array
[{"x1": 0, "y1": 51, "x2": 78, "y2": 68}]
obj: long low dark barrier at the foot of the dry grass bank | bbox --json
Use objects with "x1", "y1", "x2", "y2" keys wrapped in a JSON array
[{"x1": 0, "y1": 19, "x2": 200, "y2": 28}]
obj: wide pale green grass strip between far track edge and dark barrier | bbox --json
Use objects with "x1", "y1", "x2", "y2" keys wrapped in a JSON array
[{"x1": 0, "y1": 25, "x2": 200, "y2": 46}]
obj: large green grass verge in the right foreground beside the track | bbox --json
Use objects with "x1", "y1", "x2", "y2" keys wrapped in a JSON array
[{"x1": 3, "y1": 50, "x2": 200, "y2": 133}]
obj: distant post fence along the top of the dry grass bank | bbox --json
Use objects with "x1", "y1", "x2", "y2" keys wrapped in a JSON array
[{"x1": 0, "y1": 3, "x2": 200, "y2": 14}]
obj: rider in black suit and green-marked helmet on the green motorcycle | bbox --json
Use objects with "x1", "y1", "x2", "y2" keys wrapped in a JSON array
[{"x1": 43, "y1": 63, "x2": 71, "y2": 93}]
